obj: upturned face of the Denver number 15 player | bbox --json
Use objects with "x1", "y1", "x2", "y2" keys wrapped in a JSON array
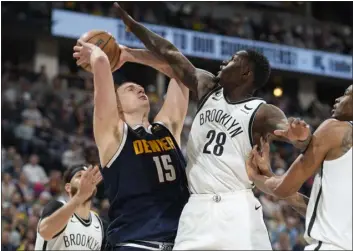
[{"x1": 117, "y1": 83, "x2": 150, "y2": 113}]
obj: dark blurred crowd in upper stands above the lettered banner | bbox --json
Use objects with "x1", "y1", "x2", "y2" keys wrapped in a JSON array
[{"x1": 2, "y1": 1, "x2": 353, "y2": 54}]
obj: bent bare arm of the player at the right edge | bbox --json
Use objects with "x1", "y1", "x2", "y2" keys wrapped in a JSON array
[{"x1": 247, "y1": 119, "x2": 342, "y2": 198}]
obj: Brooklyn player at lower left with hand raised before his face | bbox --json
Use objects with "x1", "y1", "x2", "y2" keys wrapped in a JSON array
[{"x1": 35, "y1": 166, "x2": 104, "y2": 250}]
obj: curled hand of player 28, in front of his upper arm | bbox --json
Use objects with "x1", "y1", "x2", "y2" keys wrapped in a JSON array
[{"x1": 274, "y1": 118, "x2": 311, "y2": 142}]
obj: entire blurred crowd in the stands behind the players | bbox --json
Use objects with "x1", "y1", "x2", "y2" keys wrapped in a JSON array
[{"x1": 1, "y1": 2, "x2": 346, "y2": 251}]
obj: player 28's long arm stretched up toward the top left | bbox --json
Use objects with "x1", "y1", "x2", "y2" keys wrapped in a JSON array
[{"x1": 114, "y1": 3, "x2": 215, "y2": 99}]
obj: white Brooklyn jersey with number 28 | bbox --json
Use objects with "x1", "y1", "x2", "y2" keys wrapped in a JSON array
[{"x1": 186, "y1": 88, "x2": 265, "y2": 194}]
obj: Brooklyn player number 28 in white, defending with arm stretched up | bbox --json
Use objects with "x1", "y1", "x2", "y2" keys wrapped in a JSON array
[{"x1": 115, "y1": 4, "x2": 310, "y2": 250}]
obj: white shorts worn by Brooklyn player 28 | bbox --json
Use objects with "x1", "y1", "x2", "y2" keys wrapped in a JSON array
[{"x1": 173, "y1": 189, "x2": 272, "y2": 250}]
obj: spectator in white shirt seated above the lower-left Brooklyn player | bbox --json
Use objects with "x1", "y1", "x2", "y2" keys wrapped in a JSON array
[{"x1": 23, "y1": 154, "x2": 49, "y2": 184}]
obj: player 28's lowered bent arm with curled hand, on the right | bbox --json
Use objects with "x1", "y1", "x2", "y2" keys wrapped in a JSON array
[{"x1": 252, "y1": 104, "x2": 311, "y2": 150}]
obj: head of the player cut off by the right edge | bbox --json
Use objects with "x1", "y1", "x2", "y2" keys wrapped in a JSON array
[{"x1": 332, "y1": 85, "x2": 353, "y2": 121}]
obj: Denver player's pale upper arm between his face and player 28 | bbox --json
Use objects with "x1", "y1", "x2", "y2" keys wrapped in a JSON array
[{"x1": 154, "y1": 79, "x2": 189, "y2": 145}]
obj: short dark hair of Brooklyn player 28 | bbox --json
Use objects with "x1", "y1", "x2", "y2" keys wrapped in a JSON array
[{"x1": 245, "y1": 49, "x2": 271, "y2": 89}]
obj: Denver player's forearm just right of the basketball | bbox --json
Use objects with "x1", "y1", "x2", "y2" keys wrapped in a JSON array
[{"x1": 125, "y1": 48, "x2": 175, "y2": 78}]
